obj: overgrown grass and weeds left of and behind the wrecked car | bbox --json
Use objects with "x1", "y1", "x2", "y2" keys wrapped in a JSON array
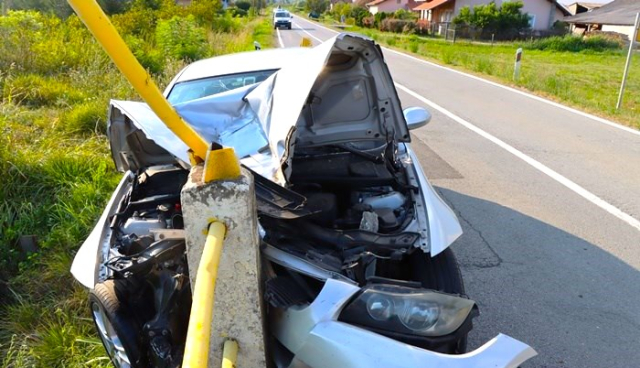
[{"x1": 0, "y1": 0, "x2": 272, "y2": 368}]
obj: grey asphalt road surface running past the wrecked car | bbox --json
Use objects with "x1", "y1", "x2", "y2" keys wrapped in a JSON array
[{"x1": 276, "y1": 16, "x2": 640, "y2": 368}]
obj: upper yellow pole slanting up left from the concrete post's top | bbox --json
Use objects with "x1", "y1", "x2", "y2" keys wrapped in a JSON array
[{"x1": 67, "y1": 0, "x2": 208, "y2": 160}]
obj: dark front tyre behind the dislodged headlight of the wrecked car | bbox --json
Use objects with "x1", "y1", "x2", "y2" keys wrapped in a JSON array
[{"x1": 410, "y1": 248, "x2": 467, "y2": 354}]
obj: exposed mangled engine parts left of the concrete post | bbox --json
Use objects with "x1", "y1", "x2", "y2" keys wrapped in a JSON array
[{"x1": 101, "y1": 166, "x2": 191, "y2": 367}]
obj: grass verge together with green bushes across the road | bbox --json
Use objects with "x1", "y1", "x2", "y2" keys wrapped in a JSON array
[{"x1": 295, "y1": 0, "x2": 640, "y2": 128}]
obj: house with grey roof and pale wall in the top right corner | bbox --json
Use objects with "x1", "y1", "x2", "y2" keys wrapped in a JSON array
[{"x1": 564, "y1": 0, "x2": 640, "y2": 39}]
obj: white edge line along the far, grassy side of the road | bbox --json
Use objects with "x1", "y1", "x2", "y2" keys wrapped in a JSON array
[{"x1": 294, "y1": 14, "x2": 640, "y2": 136}]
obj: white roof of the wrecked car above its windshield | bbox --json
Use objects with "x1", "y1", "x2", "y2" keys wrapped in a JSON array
[{"x1": 172, "y1": 47, "x2": 309, "y2": 84}]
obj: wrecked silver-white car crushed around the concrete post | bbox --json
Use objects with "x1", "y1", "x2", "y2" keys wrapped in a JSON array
[{"x1": 71, "y1": 34, "x2": 535, "y2": 368}]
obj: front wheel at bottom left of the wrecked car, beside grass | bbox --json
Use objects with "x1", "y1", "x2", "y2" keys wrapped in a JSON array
[{"x1": 89, "y1": 280, "x2": 142, "y2": 368}]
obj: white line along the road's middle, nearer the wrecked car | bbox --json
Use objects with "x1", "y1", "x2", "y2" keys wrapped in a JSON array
[{"x1": 395, "y1": 83, "x2": 640, "y2": 230}]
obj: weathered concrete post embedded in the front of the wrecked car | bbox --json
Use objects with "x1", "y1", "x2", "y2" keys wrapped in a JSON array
[{"x1": 181, "y1": 164, "x2": 266, "y2": 367}]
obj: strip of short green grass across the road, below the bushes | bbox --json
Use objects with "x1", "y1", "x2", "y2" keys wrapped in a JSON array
[{"x1": 324, "y1": 22, "x2": 640, "y2": 128}]
